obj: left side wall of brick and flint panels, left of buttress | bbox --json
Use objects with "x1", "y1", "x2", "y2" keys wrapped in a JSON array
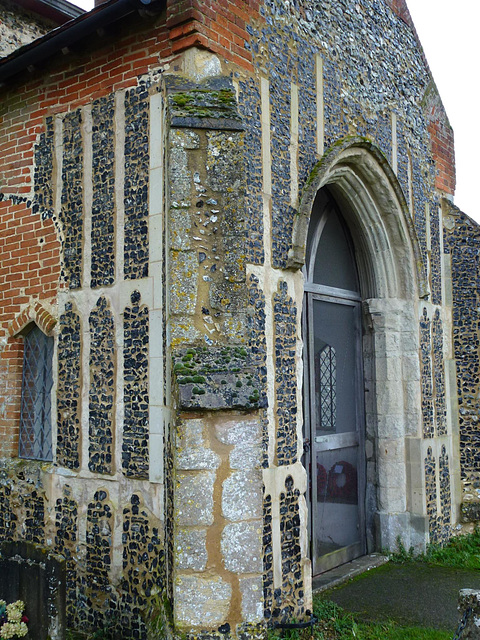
[{"x1": 0, "y1": 12, "x2": 170, "y2": 637}]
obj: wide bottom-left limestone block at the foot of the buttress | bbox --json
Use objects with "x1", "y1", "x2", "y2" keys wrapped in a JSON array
[{"x1": 175, "y1": 575, "x2": 232, "y2": 629}]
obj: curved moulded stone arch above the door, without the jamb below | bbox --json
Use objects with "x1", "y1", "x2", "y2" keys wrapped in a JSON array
[{"x1": 287, "y1": 137, "x2": 428, "y2": 298}]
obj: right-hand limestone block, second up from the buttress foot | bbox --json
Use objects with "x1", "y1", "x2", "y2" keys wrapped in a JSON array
[{"x1": 220, "y1": 520, "x2": 262, "y2": 573}]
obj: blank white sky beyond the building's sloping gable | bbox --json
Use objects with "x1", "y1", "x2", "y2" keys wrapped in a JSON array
[{"x1": 70, "y1": 0, "x2": 480, "y2": 222}]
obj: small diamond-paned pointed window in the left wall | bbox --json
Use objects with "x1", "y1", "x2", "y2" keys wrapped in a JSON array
[{"x1": 19, "y1": 326, "x2": 53, "y2": 461}]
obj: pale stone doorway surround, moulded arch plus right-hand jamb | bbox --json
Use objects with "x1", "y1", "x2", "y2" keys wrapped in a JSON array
[{"x1": 288, "y1": 138, "x2": 429, "y2": 552}]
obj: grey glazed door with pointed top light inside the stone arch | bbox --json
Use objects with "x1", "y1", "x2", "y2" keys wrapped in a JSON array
[{"x1": 303, "y1": 188, "x2": 366, "y2": 575}]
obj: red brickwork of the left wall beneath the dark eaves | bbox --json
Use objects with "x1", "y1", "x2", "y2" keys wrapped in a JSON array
[{"x1": 0, "y1": 11, "x2": 178, "y2": 456}]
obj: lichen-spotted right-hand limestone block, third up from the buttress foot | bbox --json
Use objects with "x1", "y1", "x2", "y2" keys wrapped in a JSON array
[{"x1": 222, "y1": 470, "x2": 262, "y2": 522}]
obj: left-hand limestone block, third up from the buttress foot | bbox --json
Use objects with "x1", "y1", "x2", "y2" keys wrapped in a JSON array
[{"x1": 175, "y1": 471, "x2": 215, "y2": 526}]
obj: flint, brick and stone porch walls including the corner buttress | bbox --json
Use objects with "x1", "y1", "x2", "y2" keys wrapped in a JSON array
[{"x1": 0, "y1": 0, "x2": 464, "y2": 638}]
